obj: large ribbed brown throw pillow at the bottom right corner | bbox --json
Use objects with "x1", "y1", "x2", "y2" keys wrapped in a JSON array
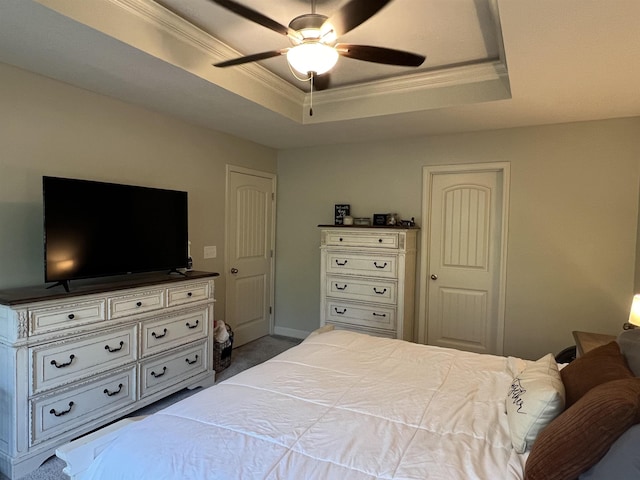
[{"x1": 524, "y1": 378, "x2": 640, "y2": 480}]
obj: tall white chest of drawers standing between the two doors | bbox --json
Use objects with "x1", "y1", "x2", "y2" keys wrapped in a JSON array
[{"x1": 320, "y1": 227, "x2": 419, "y2": 341}]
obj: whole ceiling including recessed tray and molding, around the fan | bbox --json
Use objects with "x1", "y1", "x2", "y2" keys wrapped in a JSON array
[{"x1": 0, "y1": 0, "x2": 640, "y2": 148}]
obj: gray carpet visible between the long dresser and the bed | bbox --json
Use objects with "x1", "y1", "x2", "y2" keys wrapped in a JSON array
[{"x1": 6, "y1": 336, "x2": 300, "y2": 480}]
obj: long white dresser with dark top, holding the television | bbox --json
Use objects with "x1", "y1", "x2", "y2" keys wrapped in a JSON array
[{"x1": 0, "y1": 272, "x2": 217, "y2": 478}]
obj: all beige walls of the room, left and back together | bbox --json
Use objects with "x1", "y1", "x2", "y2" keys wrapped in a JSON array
[{"x1": 0, "y1": 64, "x2": 640, "y2": 358}]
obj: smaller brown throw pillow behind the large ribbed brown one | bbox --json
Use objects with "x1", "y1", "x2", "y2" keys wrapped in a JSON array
[{"x1": 560, "y1": 342, "x2": 633, "y2": 408}]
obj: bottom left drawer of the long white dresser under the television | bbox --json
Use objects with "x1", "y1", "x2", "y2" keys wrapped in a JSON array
[{"x1": 30, "y1": 367, "x2": 136, "y2": 445}]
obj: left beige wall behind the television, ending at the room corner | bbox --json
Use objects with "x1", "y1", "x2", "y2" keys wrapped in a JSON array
[{"x1": 0, "y1": 64, "x2": 276, "y2": 316}]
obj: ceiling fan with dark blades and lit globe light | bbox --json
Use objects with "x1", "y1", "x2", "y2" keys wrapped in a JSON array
[{"x1": 210, "y1": 0, "x2": 425, "y2": 89}]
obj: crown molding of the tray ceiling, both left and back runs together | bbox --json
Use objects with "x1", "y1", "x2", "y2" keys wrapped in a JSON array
[{"x1": 34, "y1": 0, "x2": 511, "y2": 124}]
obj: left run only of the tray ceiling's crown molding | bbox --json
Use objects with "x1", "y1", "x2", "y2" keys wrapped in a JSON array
[{"x1": 34, "y1": 0, "x2": 304, "y2": 122}]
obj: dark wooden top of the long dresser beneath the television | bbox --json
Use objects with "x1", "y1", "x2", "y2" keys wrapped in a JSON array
[{"x1": 0, "y1": 271, "x2": 219, "y2": 306}]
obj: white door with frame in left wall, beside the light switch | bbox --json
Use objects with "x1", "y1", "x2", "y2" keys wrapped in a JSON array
[{"x1": 225, "y1": 166, "x2": 275, "y2": 347}]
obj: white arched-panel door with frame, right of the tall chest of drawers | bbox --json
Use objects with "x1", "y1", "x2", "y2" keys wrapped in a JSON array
[{"x1": 422, "y1": 163, "x2": 508, "y2": 354}]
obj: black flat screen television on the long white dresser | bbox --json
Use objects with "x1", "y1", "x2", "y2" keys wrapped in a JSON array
[{"x1": 42, "y1": 176, "x2": 188, "y2": 291}]
